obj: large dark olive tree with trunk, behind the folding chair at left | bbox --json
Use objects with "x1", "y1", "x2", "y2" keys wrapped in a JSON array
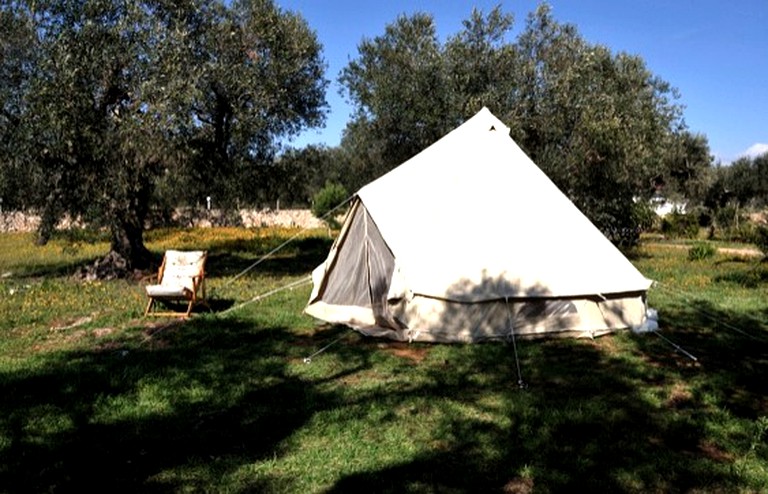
[{"x1": 0, "y1": 0, "x2": 327, "y2": 267}]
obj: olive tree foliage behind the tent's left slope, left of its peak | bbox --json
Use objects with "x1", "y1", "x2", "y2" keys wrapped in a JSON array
[{"x1": 340, "y1": 13, "x2": 454, "y2": 178}]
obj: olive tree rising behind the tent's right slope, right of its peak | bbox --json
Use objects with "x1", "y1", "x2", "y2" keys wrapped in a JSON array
[{"x1": 513, "y1": 5, "x2": 684, "y2": 244}]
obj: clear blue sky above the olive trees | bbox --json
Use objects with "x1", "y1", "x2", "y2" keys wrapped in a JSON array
[{"x1": 276, "y1": 0, "x2": 768, "y2": 163}]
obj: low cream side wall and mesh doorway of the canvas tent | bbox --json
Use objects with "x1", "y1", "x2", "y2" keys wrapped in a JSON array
[{"x1": 306, "y1": 209, "x2": 646, "y2": 342}]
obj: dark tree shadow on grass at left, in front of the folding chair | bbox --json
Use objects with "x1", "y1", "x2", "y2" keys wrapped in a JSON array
[{"x1": 0, "y1": 319, "x2": 356, "y2": 492}]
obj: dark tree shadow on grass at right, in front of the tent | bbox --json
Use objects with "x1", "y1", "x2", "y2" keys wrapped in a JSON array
[{"x1": 320, "y1": 276, "x2": 768, "y2": 493}]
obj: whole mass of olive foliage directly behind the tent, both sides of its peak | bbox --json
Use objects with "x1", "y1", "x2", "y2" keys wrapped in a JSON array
[{"x1": 340, "y1": 4, "x2": 710, "y2": 243}]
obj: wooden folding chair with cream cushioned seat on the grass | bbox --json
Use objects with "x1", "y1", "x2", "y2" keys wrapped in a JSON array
[{"x1": 144, "y1": 250, "x2": 208, "y2": 317}]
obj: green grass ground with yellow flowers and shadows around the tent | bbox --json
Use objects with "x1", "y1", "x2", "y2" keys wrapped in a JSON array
[{"x1": 0, "y1": 229, "x2": 768, "y2": 493}]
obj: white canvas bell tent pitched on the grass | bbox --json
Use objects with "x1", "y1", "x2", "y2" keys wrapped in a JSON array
[{"x1": 306, "y1": 108, "x2": 651, "y2": 342}]
